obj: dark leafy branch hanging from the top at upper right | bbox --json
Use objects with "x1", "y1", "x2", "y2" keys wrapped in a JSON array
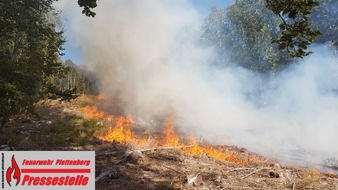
[{"x1": 266, "y1": 0, "x2": 320, "y2": 58}]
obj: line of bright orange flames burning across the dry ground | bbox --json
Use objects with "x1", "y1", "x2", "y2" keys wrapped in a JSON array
[{"x1": 82, "y1": 102, "x2": 264, "y2": 165}]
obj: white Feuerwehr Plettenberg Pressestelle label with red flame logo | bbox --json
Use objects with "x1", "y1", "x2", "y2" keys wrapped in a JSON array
[{"x1": 0, "y1": 151, "x2": 95, "y2": 190}]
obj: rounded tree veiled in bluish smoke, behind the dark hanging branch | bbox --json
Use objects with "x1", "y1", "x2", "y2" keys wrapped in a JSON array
[{"x1": 202, "y1": 0, "x2": 290, "y2": 72}]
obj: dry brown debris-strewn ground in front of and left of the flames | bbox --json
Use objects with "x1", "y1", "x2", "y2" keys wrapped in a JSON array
[{"x1": 0, "y1": 97, "x2": 338, "y2": 190}]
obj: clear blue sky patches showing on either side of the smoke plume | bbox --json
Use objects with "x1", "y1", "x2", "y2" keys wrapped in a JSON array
[{"x1": 61, "y1": 0, "x2": 235, "y2": 64}]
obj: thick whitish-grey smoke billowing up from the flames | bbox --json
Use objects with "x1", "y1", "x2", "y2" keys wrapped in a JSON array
[{"x1": 58, "y1": 0, "x2": 338, "y2": 166}]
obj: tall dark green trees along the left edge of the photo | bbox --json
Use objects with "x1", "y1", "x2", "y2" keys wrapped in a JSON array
[{"x1": 0, "y1": 0, "x2": 72, "y2": 126}]
